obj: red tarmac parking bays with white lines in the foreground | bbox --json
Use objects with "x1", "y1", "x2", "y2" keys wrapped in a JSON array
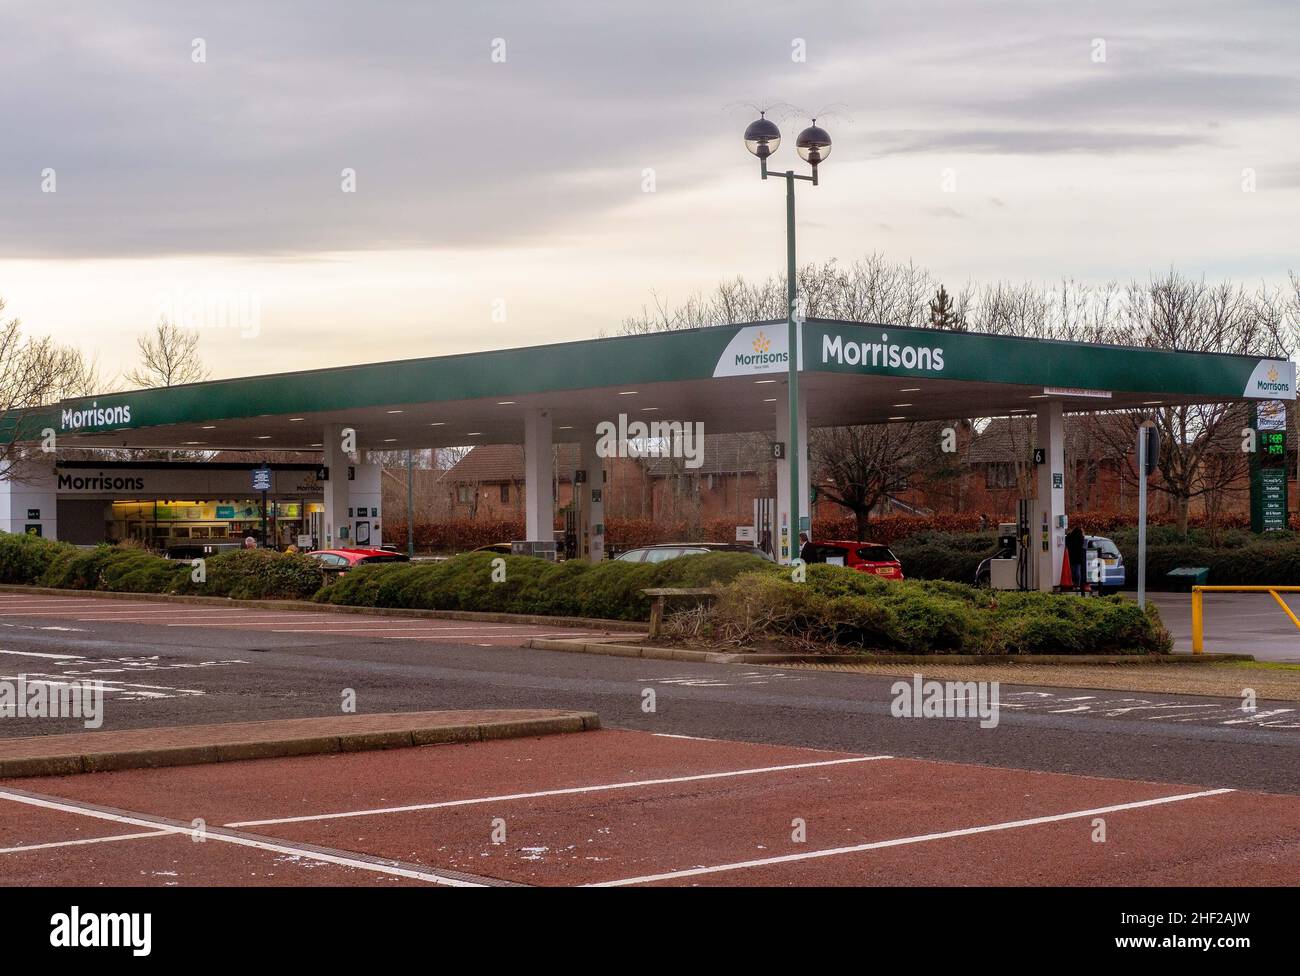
[{"x1": 0, "y1": 730, "x2": 1300, "y2": 885}]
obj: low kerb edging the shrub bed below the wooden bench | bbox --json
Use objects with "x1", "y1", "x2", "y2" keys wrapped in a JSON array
[{"x1": 524, "y1": 637, "x2": 1255, "y2": 665}]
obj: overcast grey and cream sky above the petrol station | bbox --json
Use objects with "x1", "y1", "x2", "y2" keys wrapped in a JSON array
[{"x1": 0, "y1": 0, "x2": 1300, "y2": 377}]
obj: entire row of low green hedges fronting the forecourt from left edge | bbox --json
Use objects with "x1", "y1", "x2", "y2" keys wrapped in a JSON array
[{"x1": 0, "y1": 535, "x2": 1170, "y2": 654}]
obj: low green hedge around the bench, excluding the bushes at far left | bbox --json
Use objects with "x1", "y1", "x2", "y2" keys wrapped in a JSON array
[{"x1": 316, "y1": 552, "x2": 1170, "y2": 654}]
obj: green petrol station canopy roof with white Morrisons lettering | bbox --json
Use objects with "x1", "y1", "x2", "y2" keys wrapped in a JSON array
[{"x1": 15, "y1": 318, "x2": 1296, "y2": 450}]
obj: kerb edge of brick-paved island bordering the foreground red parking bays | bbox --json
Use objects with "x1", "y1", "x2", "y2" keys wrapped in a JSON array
[{"x1": 0, "y1": 712, "x2": 601, "y2": 780}]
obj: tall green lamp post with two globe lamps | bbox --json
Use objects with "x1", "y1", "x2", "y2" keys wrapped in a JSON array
[{"x1": 745, "y1": 112, "x2": 831, "y2": 559}]
